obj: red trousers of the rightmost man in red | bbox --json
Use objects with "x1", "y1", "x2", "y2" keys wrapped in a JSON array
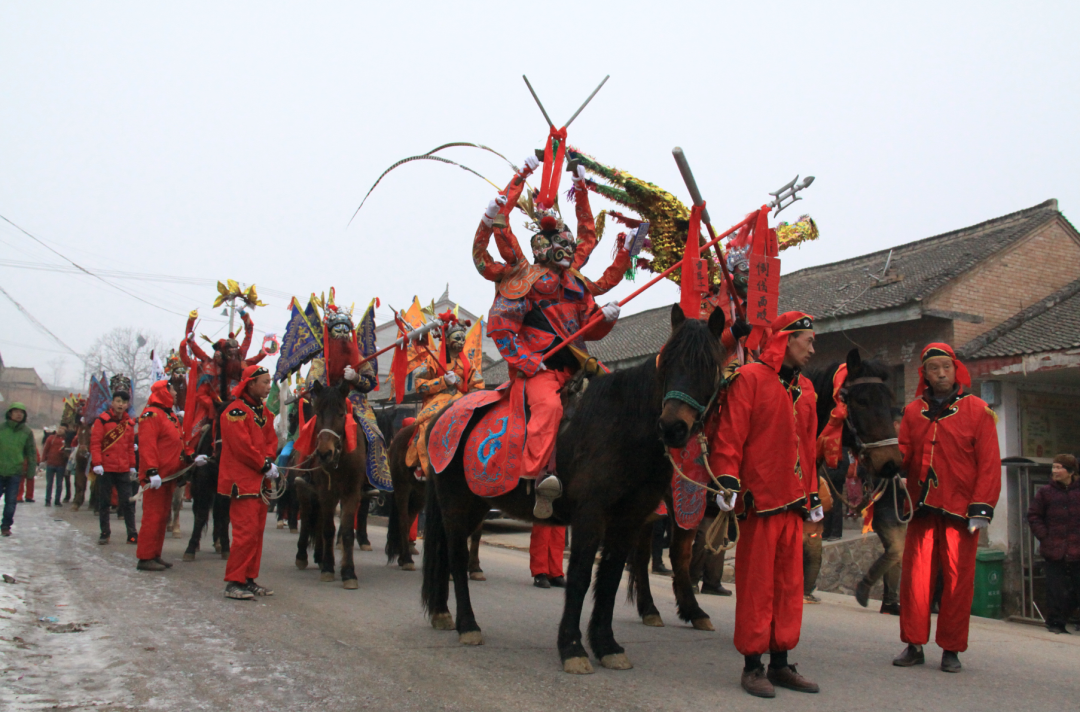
[{"x1": 900, "y1": 512, "x2": 978, "y2": 653}]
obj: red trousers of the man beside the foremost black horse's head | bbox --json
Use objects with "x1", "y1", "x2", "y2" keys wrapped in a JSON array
[{"x1": 734, "y1": 512, "x2": 802, "y2": 655}]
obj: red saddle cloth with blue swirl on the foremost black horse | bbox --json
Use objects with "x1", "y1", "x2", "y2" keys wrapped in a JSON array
[{"x1": 428, "y1": 380, "x2": 526, "y2": 497}]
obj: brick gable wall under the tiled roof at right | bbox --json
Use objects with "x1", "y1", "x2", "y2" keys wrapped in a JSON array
[{"x1": 927, "y1": 217, "x2": 1080, "y2": 348}]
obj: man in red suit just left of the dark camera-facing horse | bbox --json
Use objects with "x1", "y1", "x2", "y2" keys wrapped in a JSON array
[{"x1": 217, "y1": 365, "x2": 278, "y2": 600}]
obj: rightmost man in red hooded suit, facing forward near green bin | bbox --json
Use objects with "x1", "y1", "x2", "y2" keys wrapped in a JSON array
[{"x1": 892, "y1": 344, "x2": 1001, "y2": 672}]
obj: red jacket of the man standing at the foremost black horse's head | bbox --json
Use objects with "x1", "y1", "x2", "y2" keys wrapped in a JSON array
[{"x1": 708, "y1": 362, "x2": 818, "y2": 514}]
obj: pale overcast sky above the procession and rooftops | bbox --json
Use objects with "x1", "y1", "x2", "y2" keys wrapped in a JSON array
[{"x1": 0, "y1": 0, "x2": 1080, "y2": 381}]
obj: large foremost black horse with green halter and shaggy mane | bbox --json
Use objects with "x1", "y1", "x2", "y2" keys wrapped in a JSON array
[{"x1": 421, "y1": 305, "x2": 724, "y2": 674}]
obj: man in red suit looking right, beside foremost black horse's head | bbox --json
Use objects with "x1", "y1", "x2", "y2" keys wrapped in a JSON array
[{"x1": 710, "y1": 311, "x2": 823, "y2": 697}]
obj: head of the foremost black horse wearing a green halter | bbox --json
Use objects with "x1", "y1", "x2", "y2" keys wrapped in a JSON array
[{"x1": 657, "y1": 304, "x2": 725, "y2": 447}]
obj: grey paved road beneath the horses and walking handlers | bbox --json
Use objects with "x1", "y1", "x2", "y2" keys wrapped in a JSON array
[{"x1": 0, "y1": 503, "x2": 1080, "y2": 712}]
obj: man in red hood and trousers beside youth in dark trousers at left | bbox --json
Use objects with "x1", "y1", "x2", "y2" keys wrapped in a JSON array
[{"x1": 135, "y1": 380, "x2": 206, "y2": 572}]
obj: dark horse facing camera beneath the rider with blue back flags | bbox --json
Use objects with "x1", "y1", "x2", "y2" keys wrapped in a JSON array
[{"x1": 296, "y1": 381, "x2": 367, "y2": 590}]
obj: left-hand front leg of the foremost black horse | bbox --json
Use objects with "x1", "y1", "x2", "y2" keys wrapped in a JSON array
[{"x1": 558, "y1": 512, "x2": 609, "y2": 675}]
